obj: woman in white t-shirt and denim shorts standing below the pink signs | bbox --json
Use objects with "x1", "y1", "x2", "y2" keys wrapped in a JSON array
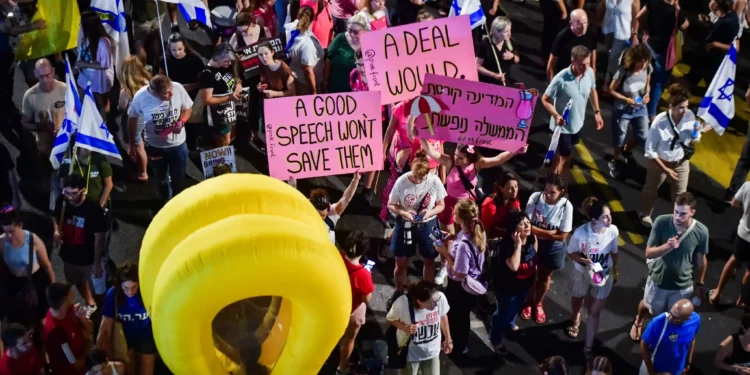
[{"x1": 387, "y1": 150, "x2": 446, "y2": 307}]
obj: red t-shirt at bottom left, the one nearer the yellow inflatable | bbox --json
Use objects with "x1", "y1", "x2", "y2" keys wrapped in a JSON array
[{"x1": 42, "y1": 307, "x2": 86, "y2": 375}]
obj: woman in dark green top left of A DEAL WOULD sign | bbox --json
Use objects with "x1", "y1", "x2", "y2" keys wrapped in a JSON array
[{"x1": 323, "y1": 13, "x2": 367, "y2": 93}]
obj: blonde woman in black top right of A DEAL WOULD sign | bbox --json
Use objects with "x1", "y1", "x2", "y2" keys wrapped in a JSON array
[{"x1": 477, "y1": 17, "x2": 520, "y2": 85}]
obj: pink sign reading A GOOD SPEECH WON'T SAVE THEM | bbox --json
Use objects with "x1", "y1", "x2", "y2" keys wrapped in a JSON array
[{"x1": 265, "y1": 91, "x2": 383, "y2": 180}]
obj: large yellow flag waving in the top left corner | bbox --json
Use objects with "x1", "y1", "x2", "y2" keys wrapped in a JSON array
[{"x1": 15, "y1": 0, "x2": 81, "y2": 60}]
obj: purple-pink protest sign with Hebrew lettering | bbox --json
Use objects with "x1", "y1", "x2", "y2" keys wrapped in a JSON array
[{"x1": 415, "y1": 74, "x2": 538, "y2": 151}]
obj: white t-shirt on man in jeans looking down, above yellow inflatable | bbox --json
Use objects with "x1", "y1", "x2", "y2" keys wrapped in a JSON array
[{"x1": 128, "y1": 82, "x2": 193, "y2": 148}]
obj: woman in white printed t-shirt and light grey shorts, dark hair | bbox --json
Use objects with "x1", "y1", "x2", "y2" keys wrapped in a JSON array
[{"x1": 566, "y1": 197, "x2": 620, "y2": 358}]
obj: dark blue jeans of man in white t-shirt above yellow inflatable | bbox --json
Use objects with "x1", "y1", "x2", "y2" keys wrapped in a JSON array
[{"x1": 146, "y1": 142, "x2": 188, "y2": 201}]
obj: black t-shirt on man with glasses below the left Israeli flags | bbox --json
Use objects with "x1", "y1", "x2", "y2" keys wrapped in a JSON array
[{"x1": 54, "y1": 196, "x2": 105, "y2": 266}]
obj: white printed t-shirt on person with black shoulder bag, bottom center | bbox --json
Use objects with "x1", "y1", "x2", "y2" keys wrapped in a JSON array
[{"x1": 385, "y1": 292, "x2": 450, "y2": 362}]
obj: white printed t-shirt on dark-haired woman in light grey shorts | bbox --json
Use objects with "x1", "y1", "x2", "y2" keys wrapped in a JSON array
[{"x1": 568, "y1": 223, "x2": 620, "y2": 272}]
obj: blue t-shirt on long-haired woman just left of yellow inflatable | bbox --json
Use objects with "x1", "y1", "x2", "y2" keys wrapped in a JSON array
[{"x1": 102, "y1": 287, "x2": 153, "y2": 346}]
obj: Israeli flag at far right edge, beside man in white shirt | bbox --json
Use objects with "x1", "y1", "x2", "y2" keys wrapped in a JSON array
[{"x1": 698, "y1": 42, "x2": 737, "y2": 135}]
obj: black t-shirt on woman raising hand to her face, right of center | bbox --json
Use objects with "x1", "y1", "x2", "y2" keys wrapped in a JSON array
[{"x1": 492, "y1": 238, "x2": 538, "y2": 296}]
